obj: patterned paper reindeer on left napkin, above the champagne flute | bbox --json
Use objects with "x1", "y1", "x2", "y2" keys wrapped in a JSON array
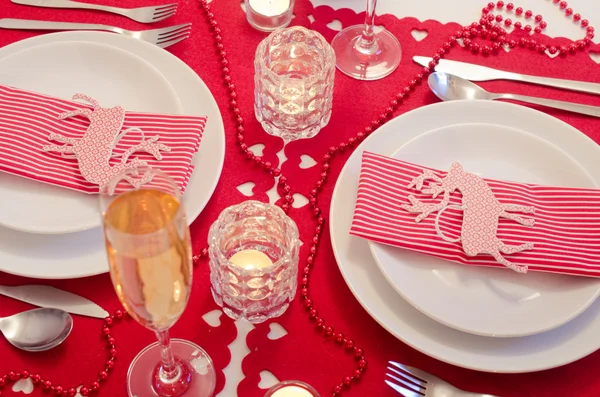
[{"x1": 42, "y1": 94, "x2": 171, "y2": 188}]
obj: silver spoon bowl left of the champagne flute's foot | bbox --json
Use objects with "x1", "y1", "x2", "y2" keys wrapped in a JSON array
[{"x1": 0, "y1": 308, "x2": 73, "y2": 352}]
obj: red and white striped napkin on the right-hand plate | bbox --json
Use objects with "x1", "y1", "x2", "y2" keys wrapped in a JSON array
[{"x1": 350, "y1": 152, "x2": 600, "y2": 277}]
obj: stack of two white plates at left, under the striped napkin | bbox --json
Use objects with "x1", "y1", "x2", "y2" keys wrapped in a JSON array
[{"x1": 0, "y1": 32, "x2": 225, "y2": 278}]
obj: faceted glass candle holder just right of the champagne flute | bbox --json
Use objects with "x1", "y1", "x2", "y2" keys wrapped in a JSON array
[{"x1": 208, "y1": 200, "x2": 300, "y2": 323}]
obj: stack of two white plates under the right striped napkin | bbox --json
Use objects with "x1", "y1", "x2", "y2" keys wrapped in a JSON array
[{"x1": 330, "y1": 101, "x2": 600, "y2": 373}]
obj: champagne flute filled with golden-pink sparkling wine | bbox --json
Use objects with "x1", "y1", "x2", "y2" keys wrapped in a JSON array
[{"x1": 100, "y1": 167, "x2": 216, "y2": 397}]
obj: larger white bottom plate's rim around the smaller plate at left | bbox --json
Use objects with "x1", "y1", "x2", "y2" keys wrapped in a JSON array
[{"x1": 0, "y1": 32, "x2": 225, "y2": 279}]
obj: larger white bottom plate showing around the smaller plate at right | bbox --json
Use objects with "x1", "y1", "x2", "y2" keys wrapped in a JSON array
[{"x1": 330, "y1": 101, "x2": 600, "y2": 373}]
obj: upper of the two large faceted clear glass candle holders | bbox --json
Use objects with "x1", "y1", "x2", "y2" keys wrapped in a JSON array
[{"x1": 254, "y1": 26, "x2": 335, "y2": 141}]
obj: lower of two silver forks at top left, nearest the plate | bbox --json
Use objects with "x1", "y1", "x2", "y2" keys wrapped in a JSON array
[{"x1": 0, "y1": 18, "x2": 192, "y2": 48}]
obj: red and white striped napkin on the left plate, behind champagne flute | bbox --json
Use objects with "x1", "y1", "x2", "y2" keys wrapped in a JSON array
[{"x1": 0, "y1": 85, "x2": 207, "y2": 193}]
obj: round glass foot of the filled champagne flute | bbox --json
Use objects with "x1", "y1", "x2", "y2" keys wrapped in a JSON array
[{"x1": 127, "y1": 339, "x2": 217, "y2": 397}]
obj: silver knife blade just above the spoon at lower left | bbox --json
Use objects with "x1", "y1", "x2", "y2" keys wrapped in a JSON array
[{"x1": 0, "y1": 285, "x2": 108, "y2": 318}]
